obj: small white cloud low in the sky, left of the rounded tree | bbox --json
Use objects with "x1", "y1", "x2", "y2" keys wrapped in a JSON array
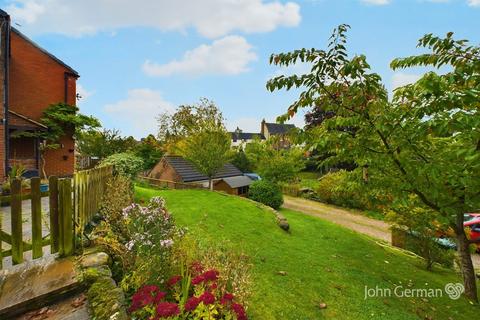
[{"x1": 104, "y1": 88, "x2": 175, "y2": 138}]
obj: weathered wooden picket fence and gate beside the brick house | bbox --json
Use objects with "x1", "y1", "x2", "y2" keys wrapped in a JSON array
[{"x1": 0, "y1": 167, "x2": 113, "y2": 269}]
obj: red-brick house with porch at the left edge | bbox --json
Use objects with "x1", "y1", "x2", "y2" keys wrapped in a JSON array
[{"x1": 0, "y1": 10, "x2": 79, "y2": 180}]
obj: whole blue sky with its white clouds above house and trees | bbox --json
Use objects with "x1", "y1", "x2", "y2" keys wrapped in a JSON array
[{"x1": 0, "y1": 0, "x2": 480, "y2": 138}]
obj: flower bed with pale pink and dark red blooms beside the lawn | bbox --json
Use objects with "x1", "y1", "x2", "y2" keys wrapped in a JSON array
[{"x1": 94, "y1": 179, "x2": 250, "y2": 320}]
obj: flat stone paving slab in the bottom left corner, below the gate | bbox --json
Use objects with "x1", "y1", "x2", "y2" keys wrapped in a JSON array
[{"x1": 0, "y1": 256, "x2": 82, "y2": 319}]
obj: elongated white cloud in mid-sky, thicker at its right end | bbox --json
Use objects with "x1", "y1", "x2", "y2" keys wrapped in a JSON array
[{"x1": 143, "y1": 36, "x2": 257, "y2": 76}]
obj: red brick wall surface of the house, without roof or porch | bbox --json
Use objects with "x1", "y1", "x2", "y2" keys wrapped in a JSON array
[{"x1": 9, "y1": 31, "x2": 76, "y2": 176}]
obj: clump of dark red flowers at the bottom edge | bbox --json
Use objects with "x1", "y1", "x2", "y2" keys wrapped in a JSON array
[{"x1": 129, "y1": 262, "x2": 247, "y2": 320}]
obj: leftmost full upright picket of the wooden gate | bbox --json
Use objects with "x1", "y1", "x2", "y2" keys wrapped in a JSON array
[{"x1": 10, "y1": 179, "x2": 23, "y2": 264}]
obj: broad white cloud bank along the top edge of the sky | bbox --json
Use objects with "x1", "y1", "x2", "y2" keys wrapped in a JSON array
[{"x1": 5, "y1": 0, "x2": 301, "y2": 38}]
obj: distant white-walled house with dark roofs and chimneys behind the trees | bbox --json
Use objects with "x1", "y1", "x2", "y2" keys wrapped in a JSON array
[{"x1": 229, "y1": 119, "x2": 296, "y2": 147}]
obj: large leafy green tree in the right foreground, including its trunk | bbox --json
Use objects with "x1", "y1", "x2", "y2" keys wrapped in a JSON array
[{"x1": 267, "y1": 25, "x2": 480, "y2": 301}]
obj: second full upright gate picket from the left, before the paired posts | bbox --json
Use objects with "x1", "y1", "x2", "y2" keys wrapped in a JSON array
[{"x1": 30, "y1": 177, "x2": 43, "y2": 259}]
